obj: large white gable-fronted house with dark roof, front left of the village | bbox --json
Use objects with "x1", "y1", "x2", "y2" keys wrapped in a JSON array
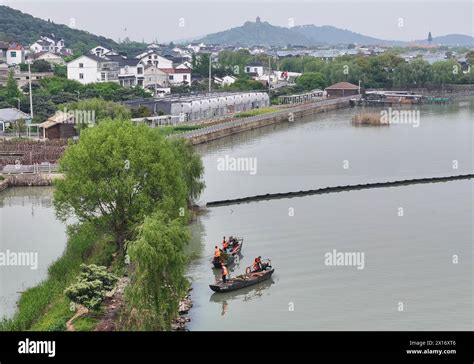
[{"x1": 67, "y1": 54, "x2": 119, "y2": 85}]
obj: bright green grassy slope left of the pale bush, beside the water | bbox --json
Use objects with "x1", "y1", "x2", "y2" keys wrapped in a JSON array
[{"x1": 0, "y1": 224, "x2": 114, "y2": 331}]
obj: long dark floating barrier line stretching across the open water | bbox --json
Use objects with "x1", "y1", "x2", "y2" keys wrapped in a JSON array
[{"x1": 206, "y1": 174, "x2": 474, "y2": 207}]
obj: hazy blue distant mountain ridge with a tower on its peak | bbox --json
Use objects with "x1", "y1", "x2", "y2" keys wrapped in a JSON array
[{"x1": 196, "y1": 18, "x2": 474, "y2": 47}]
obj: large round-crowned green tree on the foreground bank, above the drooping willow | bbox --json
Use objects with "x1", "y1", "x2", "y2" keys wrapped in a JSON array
[{"x1": 54, "y1": 120, "x2": 202, "y2": 254}]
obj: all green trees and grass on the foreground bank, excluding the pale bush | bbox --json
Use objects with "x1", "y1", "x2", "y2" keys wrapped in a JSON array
[{"x1": 0, "y1": 120, "x2": 204, "y2": 331}]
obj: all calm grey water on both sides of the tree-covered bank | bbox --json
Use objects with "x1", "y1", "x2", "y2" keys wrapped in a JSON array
[{"x1": 0, "y1": 101, "x2": 474, "y2": 330}]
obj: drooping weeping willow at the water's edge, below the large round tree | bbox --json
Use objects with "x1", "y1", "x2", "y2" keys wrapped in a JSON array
[{"x1": 125, "y1": 212, "x2": 189, "y2": 330}]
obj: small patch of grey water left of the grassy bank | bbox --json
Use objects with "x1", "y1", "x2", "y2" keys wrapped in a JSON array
[{"x1": 0, "y1": 187, "x2": 67, "y2": 318}]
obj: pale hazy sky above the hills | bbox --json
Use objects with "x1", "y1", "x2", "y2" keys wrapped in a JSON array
[{"x1": 0, "y1": 0, "x2": 474, "y2": 42}]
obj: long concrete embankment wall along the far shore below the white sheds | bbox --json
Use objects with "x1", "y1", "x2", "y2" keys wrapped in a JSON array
[{"x1": 178, "y1": 96, "x2": 358, "y2": 145}]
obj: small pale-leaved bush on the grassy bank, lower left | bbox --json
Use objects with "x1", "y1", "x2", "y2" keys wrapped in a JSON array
[{"x1": 64, "y1": 264, "x2": 118, "y2": 310}]
